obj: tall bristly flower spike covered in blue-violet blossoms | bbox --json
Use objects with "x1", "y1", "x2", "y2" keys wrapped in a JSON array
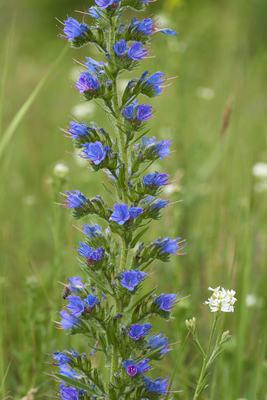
[{"x1": 53, "y1": 0, "x2": 185, "y2": 400}]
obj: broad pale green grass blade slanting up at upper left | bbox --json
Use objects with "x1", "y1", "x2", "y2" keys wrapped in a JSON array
[{"x1": 0, "y1": 45, "x2": 69, "y2": 159}]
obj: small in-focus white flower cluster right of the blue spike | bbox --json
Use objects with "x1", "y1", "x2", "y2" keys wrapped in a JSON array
[{"x1": 204, "y1": 286, "x2": 236, "y2": 312}]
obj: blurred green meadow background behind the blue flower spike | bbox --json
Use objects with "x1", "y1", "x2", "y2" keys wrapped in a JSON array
[{"x1": 0, "y1": 0, "x2": 267, "y2": 400}]
